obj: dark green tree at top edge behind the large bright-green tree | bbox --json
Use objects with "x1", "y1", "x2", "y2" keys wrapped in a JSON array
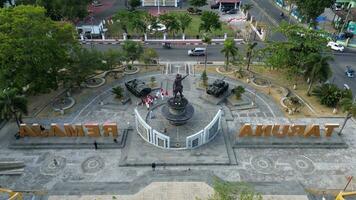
[{"x1": 16, "y1": 0, "x2": 92, "y2": 21}]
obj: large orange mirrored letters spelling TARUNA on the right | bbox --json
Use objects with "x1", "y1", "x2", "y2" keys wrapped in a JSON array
[{"x1": 236, "y1": 124, "x2": 340, "y2": 138}]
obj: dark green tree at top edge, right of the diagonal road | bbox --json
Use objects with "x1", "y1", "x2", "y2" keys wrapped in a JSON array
[{"x1": 295, "y1": 0, "x2": 334, "y2": 26}]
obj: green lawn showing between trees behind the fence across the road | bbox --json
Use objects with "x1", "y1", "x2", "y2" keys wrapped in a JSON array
[{"x1": 107, "y1": 11, "x2": 236, "y2": 39}]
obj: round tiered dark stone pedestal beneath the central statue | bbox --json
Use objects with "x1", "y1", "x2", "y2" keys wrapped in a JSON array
[{"x1": 162, "y1": 97, "x2": 194, "y2": 126}]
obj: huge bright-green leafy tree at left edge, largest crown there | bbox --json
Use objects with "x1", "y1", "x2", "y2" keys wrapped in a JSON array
[{"x1": 0, "y1": 6, "x2": 78, "y2": 94}]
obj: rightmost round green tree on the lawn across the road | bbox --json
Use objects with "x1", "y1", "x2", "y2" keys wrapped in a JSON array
[{"x1": 199, "y1": 11, "x2": 221, "y2": 33}]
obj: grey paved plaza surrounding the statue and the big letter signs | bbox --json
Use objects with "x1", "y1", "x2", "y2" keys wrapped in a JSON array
[{"x1": 0, "y1": 69, "x2": 356, "y2": 200}]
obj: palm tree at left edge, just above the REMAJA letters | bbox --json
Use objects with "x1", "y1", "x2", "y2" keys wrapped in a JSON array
[{"x1": 0, "y1": 88, "x2": 27, "y2": 127}]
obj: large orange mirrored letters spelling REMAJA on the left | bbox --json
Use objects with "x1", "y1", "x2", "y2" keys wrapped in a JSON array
[{"x1": 20, "y1": 123, "x2": 118, "y2": 138}]
